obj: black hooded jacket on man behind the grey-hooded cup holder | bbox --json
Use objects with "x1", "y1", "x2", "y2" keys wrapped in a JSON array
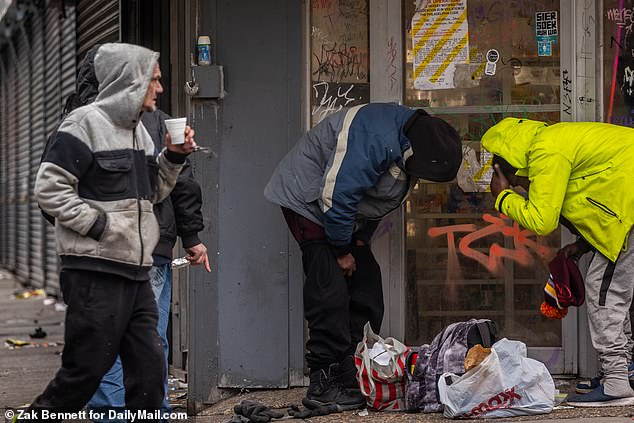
[{"x1": 42, "y1": 45, "x2": 204, "y2": 259}]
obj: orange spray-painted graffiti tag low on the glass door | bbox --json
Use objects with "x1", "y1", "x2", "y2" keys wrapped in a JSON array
[{"x1": 427, "y1": 214, "x2": 555, "y2": 279}]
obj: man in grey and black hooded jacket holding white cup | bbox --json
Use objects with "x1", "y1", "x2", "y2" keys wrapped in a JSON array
[{"x1": 25, "y1": 44, "x2": 196, "y2": 420}]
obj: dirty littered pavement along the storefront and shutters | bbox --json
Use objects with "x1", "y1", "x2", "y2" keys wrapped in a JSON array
[{"x1": 0, "y1": 269, "x2": 634, "y2": 423}]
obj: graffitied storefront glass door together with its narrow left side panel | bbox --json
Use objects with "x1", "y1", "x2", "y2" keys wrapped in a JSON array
[{"x1": 307, "y1": 0, "x2": 576, "y2": 373}]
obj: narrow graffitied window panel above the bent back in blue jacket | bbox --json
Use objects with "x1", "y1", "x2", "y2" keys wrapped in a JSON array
[{"x1": 310, "y1": 0, "x2": 370, "y2": 125}]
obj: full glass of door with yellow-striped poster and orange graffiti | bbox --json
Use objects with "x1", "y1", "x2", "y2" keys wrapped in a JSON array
[{"x1": 403, "y1": 0, "x2": 562, "y2": 347}]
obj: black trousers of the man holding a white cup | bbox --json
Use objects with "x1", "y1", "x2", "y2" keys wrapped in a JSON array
[{"x1": 30, "y1": 270, "x2": 165, "y2": 420}]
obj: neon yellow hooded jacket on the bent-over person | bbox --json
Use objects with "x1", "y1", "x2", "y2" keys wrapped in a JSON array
[{"x1": 482, "y1": 118, "x2": 634, "y2": 262}]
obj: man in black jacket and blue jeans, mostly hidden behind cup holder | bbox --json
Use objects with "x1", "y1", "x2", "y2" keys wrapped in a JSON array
[{"x1": 42, "y1": 44, "x2": 211, "y2": 422}]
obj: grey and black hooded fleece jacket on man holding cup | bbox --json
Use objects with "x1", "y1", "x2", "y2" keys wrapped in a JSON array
[{"x1": 35, "y1": 44, "x2": 185, "y2": 280}]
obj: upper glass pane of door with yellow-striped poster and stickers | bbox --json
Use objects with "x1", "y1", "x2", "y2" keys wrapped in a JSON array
[{"x1": 403, "y1": 0, "x2": 560, "y2": 107}]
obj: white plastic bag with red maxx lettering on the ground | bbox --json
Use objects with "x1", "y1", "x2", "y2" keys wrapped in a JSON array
[{"x1": 438, "y1": 338, "x2": 555, "y2": 419}]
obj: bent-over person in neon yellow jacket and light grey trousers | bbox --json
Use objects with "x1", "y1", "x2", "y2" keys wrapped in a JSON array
[{"x1": 482, "y1": 118, "x2": 634, "y2": 406}]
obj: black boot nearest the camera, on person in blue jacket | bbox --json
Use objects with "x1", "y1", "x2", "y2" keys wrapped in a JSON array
[{"x1": 302, "y1": 363, "x2": 365, "y2": 411}]
